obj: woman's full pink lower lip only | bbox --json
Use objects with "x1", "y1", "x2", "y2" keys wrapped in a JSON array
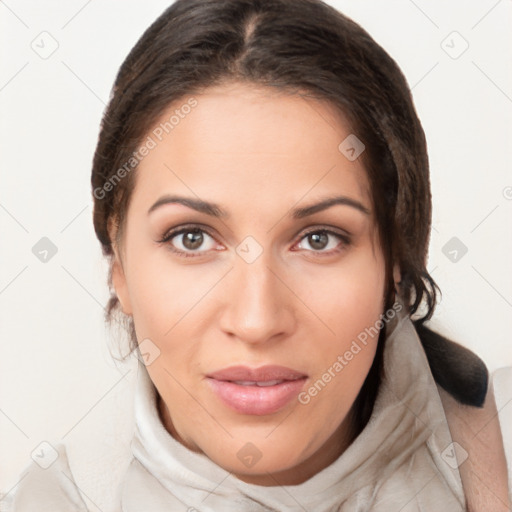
[{"x1": 208, "y1": 377, "x2": 306, "y2": 416}]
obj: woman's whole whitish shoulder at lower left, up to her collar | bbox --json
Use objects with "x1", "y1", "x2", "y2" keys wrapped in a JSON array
[{"x1": 5, "y1": 358, "x2": 138, "y2": 512}]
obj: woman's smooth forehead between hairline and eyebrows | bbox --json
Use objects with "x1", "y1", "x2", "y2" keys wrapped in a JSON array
[{"x1": 134, "y1": 83, "x2": 371, "y2": 215}]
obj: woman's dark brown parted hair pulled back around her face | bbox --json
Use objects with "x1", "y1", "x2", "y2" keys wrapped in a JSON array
[{"x1": 92, "y1": 0, "x2": 448, "y2": 432}]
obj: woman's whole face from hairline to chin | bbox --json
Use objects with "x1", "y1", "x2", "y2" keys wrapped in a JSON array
[{"x1": 113, "y1": 83, "x2": 385, "y2": 485}]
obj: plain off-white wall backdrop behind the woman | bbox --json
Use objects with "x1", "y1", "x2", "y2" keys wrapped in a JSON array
[{"x1": 0, "y1": 0, "x2": 512, "y2": 491}]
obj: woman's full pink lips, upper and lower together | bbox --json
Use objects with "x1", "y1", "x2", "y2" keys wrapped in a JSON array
[{"x1": 207, "y1": 365, "x2": 307, "y2": 416}]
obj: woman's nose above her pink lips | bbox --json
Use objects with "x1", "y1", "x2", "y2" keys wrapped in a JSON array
[{"x1": 220, "y1": 255, "x2": 295, "y2": 345}]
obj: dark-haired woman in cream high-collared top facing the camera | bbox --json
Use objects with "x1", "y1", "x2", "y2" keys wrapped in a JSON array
[{"x1": 6, "y1": 0, "x2": 509, "y2": 511}]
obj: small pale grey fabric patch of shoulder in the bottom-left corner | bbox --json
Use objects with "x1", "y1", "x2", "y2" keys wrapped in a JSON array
[{"x1": 6, "y1": 443, "x2": 87, "y2": 512}]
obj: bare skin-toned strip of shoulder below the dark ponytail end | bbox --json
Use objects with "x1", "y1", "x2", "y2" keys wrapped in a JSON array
[{"x1": 438, "y1": 379, "x2": 510, "y2": 512}]
